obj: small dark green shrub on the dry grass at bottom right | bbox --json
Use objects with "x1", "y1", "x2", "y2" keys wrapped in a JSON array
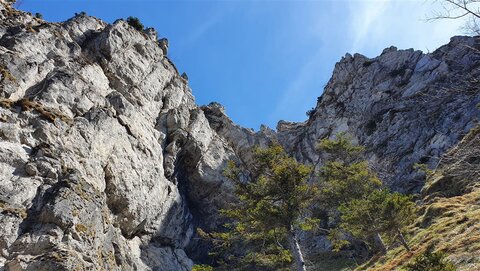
[{"x1": 406, "y1": 245, "x2": 457, "y2": 271}]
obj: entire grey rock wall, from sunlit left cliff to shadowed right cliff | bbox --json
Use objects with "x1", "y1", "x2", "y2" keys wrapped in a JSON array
[{"x1": 0, "y1": 0, "x2": 480, "y2": 270}]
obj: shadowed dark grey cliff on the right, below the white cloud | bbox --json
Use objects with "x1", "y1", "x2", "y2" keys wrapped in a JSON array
[{"x1": 277, "y1": 37, "x2": 480, "y2": 193}]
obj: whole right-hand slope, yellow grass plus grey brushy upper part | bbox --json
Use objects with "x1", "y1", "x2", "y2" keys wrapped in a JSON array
[{"x1": 357, "y1": 127, "x2": 480, "y2": 271}]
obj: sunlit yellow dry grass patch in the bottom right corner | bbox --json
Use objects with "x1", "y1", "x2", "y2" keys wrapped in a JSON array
[{"x1": 358, "y1": 186, "x2": 480, "y2": 271}]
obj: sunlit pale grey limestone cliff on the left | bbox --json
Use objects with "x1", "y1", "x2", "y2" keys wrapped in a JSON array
[{"x1": 0, "y1": 3, "x2": 197, "y2": 270}]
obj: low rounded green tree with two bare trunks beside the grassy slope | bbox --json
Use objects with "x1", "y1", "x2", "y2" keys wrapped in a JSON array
[{"x1": 338, "y1": 189, "x2": 415, "y2": 254}]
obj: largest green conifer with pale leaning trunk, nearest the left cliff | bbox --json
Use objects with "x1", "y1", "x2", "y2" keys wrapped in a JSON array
[{"x1": 212, "y1": 145, "x2": 318, "y2": 270}]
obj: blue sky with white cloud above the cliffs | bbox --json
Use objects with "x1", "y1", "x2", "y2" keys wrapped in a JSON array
[{"x1": 18, "y1": 0, "x2": 461, "y2": 130}]
